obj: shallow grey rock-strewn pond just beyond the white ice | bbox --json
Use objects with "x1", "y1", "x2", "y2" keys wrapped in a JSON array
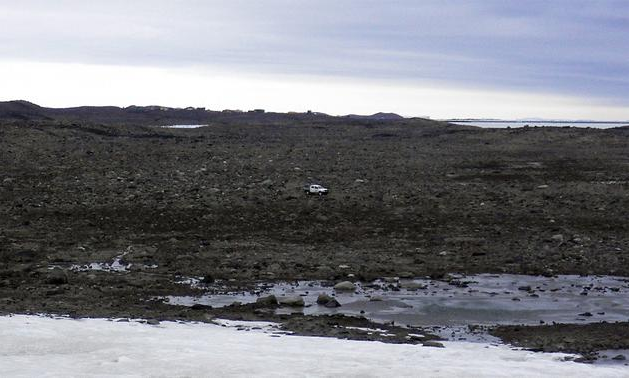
[{"x1": 165, "y1": 274, "x2": 628, "y2": 327}]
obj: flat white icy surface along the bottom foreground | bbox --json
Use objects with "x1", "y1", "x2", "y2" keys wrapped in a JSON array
[{"x1": 0, "y1": 315, "x2": 628, "y2": 377}]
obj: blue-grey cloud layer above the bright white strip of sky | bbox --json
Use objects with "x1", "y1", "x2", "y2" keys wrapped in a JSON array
[{"x1": 0, "y1": 0, "x2": 628, "y2": 118}]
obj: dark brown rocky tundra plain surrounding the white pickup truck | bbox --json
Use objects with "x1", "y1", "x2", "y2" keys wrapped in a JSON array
[{"x1": 0, "y1": 107, "x2": 628, "y2": 358}]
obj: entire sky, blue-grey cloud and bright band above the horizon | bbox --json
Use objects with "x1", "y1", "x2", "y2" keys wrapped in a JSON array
[{"x1": 0, "y1": 0, "x2": 629, "y2": 120}]
